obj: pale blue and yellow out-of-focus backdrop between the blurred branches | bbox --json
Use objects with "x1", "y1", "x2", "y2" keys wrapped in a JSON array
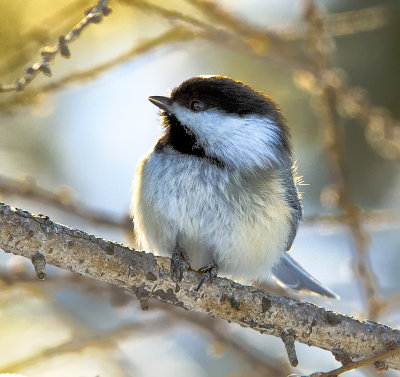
[{"x1": 0, "y1": 0, "x2": 400, "y2": 377}]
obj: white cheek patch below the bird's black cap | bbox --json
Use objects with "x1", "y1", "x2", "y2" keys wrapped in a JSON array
[{"x1": 172, "y1": 104, "x2": 284, "y2": 168}]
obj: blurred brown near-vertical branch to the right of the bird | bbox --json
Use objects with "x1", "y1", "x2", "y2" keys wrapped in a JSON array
[{"x1": 304, "y1": 0, "x2": 381, "y2": 319}]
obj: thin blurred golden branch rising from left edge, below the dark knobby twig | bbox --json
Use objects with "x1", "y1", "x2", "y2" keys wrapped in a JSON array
[{"x1": 0, "y1": 26, "x2": 199, "y2": 112}]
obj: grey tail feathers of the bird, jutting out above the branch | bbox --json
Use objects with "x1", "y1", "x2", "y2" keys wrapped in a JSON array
[{"x1": 272, "y1": 253, "x2": 339, "y2": 299}]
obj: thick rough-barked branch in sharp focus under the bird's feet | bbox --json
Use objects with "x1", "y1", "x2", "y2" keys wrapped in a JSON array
[{"x1": 0, "y1": 204, "x2": 400, "y2": 369}]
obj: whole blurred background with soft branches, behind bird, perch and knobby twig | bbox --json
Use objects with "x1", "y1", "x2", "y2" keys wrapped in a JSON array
[{"x1": 0, "y1": 0, "x2": 400, "y2": 377}]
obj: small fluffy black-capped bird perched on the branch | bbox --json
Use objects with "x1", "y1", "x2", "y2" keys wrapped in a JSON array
[{"x1": 131, "y1": 75, "x2": 338, "y2": 298}]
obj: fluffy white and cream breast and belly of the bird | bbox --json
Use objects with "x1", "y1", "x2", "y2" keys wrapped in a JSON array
[{"x1": 131, "y1": 147, "x2": 291, "y2": 281}]
